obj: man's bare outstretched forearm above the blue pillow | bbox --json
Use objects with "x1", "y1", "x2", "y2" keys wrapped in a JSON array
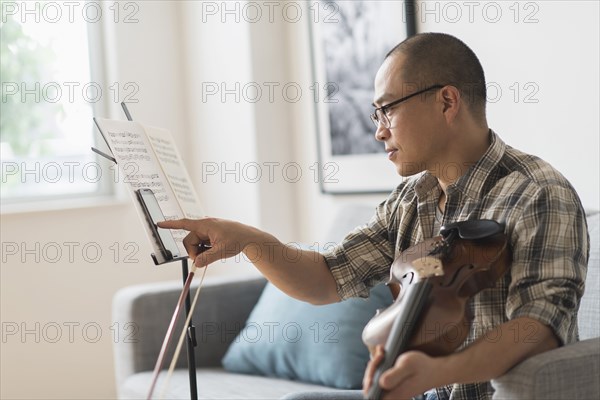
[{"x1": 242, "y1": 228, "x2": 340, "y2": 304}]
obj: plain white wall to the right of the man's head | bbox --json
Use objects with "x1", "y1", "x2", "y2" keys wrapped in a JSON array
[{"x1": 419, "y1": 1, "x2": 600, "y2": 209}]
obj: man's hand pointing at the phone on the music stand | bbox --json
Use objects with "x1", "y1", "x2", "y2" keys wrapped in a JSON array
[{"x1": 157, "y1": 218, "x2": 254, "y2": 268}]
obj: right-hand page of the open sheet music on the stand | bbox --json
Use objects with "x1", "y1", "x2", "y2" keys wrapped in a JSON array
[{"x1": 145, "y1": 126, "x2": 205, "y2": 219}]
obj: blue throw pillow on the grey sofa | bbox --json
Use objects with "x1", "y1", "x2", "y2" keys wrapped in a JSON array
[{"x1": 222, "y1": 283, "x2": 392, "y2": 389}]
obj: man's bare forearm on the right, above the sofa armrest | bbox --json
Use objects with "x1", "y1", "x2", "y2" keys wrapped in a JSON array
[{"x1": 444, "y1": 318, "x2": 558, "y2": 384}]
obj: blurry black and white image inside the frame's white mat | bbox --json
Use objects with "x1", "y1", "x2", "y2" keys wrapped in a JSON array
[{"x1": 317, "y1": 1, "x2": 399, "y2": 156}]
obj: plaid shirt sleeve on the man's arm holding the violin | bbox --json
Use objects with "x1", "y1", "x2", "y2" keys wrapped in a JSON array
[{"x1": 506, "y1": 186, "x2": 589, "y2": 344}]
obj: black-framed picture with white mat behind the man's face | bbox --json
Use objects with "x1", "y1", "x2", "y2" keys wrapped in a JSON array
[{"x1": 310, "y1": 0, "x2": 415, "y2": 194}]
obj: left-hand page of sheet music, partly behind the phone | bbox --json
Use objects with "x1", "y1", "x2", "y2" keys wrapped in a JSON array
[{"x1": 94, "y1": 118, "x2": 187, "y2": 262}]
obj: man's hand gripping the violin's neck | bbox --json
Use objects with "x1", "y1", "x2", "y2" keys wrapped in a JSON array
[{"x1": 363, "y1": 346, "x2": 450, "y2": 400}]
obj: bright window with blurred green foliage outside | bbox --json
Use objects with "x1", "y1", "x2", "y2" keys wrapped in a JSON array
[{"x1": 0, "y1": 1, "x2": 108, "y2": 204}]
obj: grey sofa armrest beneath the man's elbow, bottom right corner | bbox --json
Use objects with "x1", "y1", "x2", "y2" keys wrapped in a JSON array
[{"x1": 492, "y1": 338, "x2": 600, "y2": 400}]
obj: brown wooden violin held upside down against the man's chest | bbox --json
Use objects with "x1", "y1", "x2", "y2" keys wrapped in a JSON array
[{"x1": 362, "y1": 220, "x2": 511, "y2": 400}]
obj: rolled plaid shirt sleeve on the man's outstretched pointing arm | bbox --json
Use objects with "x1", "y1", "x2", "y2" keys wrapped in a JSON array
[{"x1": 323, "y1": 190, "x2": 397, "y2": 299}]
